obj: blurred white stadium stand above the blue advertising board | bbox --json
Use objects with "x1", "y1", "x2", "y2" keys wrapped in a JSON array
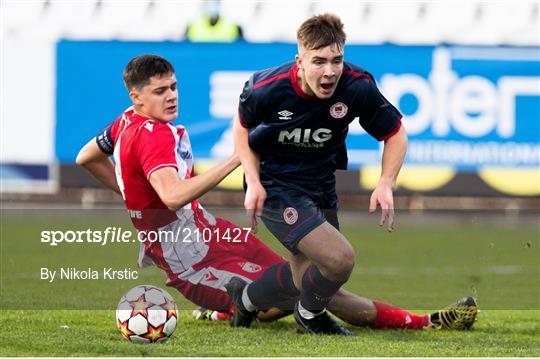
[{"x1": 2, "y1": 0, "x2": 539, "y2": 45}]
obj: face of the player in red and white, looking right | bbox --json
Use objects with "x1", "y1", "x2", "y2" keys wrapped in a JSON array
[{"x1": 130, "y1": 74, "x2": 178, "y2": 122}]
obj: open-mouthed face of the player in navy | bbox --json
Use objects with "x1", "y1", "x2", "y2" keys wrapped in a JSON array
[{"x1": 296, "y1": 45, "x2": 343, "y2": 99}]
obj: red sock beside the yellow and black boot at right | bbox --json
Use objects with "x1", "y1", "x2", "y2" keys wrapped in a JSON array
[{"x1": 373, "y1": 300, "x2": 429, "y2": 329}]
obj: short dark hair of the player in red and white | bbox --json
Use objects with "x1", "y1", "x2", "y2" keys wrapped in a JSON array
[{"x1": 123, "y1": 55, "x2": 174, "y2": 91}]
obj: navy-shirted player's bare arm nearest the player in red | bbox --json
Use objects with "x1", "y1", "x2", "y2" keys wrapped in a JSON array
[{"x1": 233, "y1": 115, "x2": 266, "y2": 233}]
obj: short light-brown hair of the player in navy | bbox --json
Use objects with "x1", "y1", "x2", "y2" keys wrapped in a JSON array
[{"x1": 296, "y1": 13, "x2": 347, "y2": 50}]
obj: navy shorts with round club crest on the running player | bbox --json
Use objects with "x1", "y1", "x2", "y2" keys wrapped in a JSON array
[{"x1": 262, "y1": 182, "x2": 339, "y2": 254}]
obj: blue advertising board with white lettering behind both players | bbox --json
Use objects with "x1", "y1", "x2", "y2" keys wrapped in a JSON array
[{"x1": 55, "y1": 41, "x2": 540, "y2": 171}]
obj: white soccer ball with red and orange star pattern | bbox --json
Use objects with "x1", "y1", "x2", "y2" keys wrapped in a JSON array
[{"x1": 116, "y1": 285, "x2": 178, "y2": 343}]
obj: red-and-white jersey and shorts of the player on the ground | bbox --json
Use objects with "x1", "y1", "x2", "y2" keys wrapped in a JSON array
[{"x1": 96, "y1": 107, "x2": 283, "y2": 304}]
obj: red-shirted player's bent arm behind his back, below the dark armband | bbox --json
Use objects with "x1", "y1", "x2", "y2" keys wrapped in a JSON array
[{"x1": 75, "y1": 137, "x2": 120, "y2": 194}]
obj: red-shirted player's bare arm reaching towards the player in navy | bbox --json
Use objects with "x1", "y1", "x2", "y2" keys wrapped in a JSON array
[{"x1": 149, "y1": 154, "x2": 240, "y2": 211}]
